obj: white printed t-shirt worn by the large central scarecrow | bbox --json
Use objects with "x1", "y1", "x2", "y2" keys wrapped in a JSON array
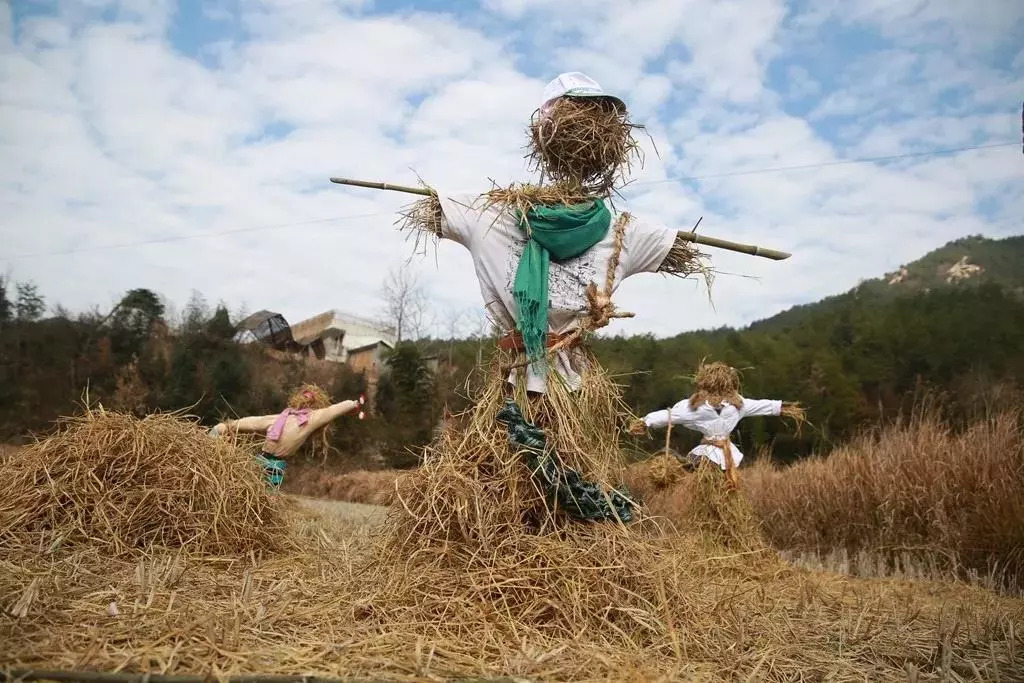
[{"x1": 438, "y1": 193, "x2": 676, "y2": 392}]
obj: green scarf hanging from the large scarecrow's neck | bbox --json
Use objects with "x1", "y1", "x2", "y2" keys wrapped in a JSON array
[{"x1": 512, "y1": 200, "x2": 611, "y2": 368}]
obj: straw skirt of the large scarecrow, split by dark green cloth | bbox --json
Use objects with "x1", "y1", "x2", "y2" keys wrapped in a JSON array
[{"x1": 382, "y1": 353, "x2": 625, "y2": 545}]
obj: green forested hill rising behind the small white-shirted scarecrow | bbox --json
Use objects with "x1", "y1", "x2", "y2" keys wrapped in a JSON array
[{"x1": 595, "y1": 232, "x2": 1024, "y2": 458}]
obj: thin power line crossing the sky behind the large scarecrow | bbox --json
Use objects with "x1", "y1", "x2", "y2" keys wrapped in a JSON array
[{"x1": 8, "y1": 139, "x2": 1024, "y2": 260}]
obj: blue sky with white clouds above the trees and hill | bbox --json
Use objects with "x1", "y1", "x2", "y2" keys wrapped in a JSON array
[{"x1": 0, "y1": 0, "x2": 1024, "y2": 335}]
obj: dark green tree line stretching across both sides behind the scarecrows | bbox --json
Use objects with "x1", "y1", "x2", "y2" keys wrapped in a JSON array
[{"x1": 0, "y1": 279, "x2": 1024, "y2": 467}]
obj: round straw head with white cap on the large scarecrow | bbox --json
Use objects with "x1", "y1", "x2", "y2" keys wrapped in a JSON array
[{"x1": 528, "y1": 72, "x2": 640, "y2": 195}]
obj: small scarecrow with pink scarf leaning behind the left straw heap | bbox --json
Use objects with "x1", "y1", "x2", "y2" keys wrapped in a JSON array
[{"x1": 209, "y1": 384, "x2": 366, "y2": 488}]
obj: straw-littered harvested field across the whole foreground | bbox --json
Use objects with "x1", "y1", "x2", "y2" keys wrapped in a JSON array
[{"x1": 0, "y1": 409, "x2": 1024, "y2": 681}]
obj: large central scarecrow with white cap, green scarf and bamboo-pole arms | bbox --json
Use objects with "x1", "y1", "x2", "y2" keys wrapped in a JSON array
[{"x1": 331, "y1": 72, "x2": 788, "y2": 521}]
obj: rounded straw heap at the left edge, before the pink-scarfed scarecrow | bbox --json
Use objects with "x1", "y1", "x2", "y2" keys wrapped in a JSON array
[{"x1": 0, "y1": 409, "x2": 281, "y2": 553}]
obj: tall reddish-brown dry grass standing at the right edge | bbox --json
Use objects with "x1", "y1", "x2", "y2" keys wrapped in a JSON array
[{"x1": 743, "y1": 411, "x2": 1024, "y2": 585}]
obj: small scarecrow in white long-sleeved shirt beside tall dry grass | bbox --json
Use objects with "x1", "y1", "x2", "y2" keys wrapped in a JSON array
[{"x1": 630, "y1": 362, "x2": 805, "y2": 488}]
